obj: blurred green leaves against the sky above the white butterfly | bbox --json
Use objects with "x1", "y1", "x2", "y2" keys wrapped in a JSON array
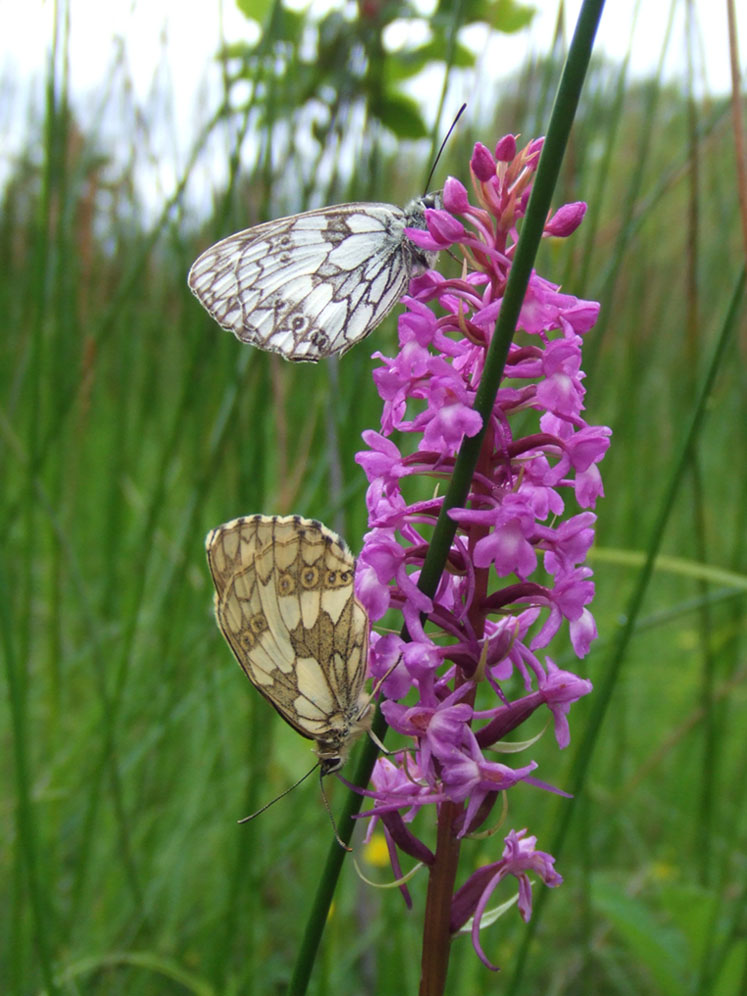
[{"x1": 231, "y1": 0, "x2": 533, "y2": 137}]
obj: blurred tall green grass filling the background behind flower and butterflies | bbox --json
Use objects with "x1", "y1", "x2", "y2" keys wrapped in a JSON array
[{"x1": 0, "y1": 1, "x2": 747, "y2": 996}]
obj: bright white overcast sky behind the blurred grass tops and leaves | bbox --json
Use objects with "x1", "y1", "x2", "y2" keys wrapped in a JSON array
[{"x1": 0, "y1": 0, "x2": 747, "y2": 210}]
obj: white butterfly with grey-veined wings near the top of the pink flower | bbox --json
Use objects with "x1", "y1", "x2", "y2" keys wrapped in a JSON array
[{"x1": 189, "y1": 193, "x2": 441, "y2": 363}]
